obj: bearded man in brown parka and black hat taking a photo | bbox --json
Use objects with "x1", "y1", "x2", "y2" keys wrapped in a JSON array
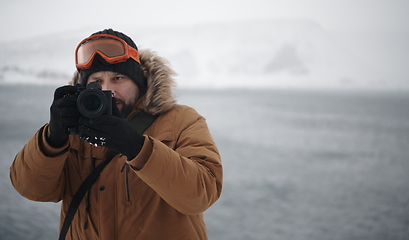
[{"x1": 10, "y1": 29, "x2": 222, "y2": 240}]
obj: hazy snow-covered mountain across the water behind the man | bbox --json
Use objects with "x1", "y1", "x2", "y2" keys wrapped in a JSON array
[{"x1": 0, "y1": 20, "x2": 409, "y2": 88}]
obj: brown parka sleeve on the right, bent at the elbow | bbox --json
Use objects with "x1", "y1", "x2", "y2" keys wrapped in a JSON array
[{"x1": 128, "y1": 107, "x2": 223, "y2": 215}]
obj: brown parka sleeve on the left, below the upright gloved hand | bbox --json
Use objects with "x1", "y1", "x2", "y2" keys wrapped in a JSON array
[{"x1": 10, "y1": 125, "x2": 68, "y2": 202}]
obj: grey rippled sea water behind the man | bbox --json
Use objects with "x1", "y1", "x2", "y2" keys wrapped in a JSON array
[{"x1": 0, "y1": 85, "x2": 409, "y2": 240}]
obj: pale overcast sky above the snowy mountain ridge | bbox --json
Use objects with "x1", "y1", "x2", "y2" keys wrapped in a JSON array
[{"x1": 0, "y1": 0, "x2": 409, "y2": 41}]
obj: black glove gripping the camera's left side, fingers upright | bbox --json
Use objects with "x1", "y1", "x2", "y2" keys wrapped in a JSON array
[{"x1": 47, "y1": 85, "x2": 80, "y2": 147}]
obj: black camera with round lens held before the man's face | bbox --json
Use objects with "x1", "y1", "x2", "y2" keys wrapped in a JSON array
[{"x1": 68, "y1": 82, "x2": 112, "y2": 135}]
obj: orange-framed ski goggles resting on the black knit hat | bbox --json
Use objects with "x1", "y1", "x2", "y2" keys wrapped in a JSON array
[{"x1": 75, "y1": 34, "x2": 140, "y2": 70}]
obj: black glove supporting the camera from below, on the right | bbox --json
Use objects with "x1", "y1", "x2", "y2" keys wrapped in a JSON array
[{"x1": 79, "y1": 104, "x2": 145, "y2": 160}]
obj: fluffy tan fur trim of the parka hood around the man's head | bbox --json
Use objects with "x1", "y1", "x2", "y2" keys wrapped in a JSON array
[{"x1": 69, "y1": 49, "x2": 176, "y2": 115}]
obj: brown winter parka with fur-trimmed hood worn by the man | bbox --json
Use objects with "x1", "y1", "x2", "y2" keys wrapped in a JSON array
[{"x1": 10, "y1": 50, "x2": 222, "y2": 240}]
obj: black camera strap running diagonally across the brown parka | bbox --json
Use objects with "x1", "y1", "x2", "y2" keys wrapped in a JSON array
[{"x1": 58, "y1": 111, "x2": 158, "y2": 240}]
